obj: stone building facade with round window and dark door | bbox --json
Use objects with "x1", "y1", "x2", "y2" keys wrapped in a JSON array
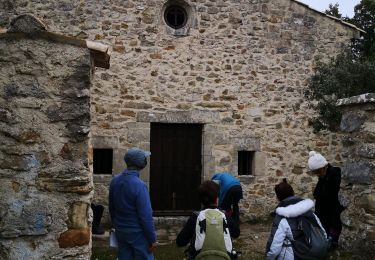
[{"x1": 0, "y1": 0, "x2": 360, "y2": 225}]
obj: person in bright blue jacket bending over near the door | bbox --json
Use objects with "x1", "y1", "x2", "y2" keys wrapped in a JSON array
[{"x1": 212, "y1": 172, "x2": 243, "y2": 228}]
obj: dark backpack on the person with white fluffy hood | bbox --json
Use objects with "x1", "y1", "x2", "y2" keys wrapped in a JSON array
[{"x1": 287, "y1": 215, "x2": 329, "y2": 260}]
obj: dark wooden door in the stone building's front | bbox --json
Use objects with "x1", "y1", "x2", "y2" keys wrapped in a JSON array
[{"x1": 150, "y1": 123, "x2": 202, "y2": 215}]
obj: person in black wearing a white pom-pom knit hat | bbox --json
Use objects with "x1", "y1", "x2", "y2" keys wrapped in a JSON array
[{"x1": 308, "y1": 151, "x2": 344, "y2": 247}]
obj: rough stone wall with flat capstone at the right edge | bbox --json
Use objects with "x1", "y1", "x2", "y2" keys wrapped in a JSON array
[{"x1": 338, "y1": 94, "x2": 375, "y2": 259}]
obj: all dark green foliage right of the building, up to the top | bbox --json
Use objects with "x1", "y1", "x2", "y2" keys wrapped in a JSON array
[{"x1": 305, "y1": 0, "x2": 375, "y2": 131}]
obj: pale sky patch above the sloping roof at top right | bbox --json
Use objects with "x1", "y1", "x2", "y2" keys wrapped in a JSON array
[{"x1": 298, "y1": 0, "x2": 361, "y2": 17}]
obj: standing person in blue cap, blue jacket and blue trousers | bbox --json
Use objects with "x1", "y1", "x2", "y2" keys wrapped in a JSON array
[{"x1": 109, "y1": 148, "x2": 156, "y2": 260}]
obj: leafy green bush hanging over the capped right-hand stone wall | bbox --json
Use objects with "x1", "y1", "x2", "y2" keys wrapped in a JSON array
[{"x1": 305, "y1": 51, "x2": 375, "y2": 131}]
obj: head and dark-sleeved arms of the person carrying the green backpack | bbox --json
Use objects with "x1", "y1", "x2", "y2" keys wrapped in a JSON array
[{"x1": 176, "y1": 180, "x2": 240, "y2": 259}]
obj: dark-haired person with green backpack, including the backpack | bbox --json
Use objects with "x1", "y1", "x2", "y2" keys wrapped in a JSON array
[{"x1": 176, "y1": 180, "x2": 240, "y2": 260}]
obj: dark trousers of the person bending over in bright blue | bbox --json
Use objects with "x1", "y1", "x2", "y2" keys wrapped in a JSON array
[{"x1": 220, "y1": 185, "x2": 243, "y2": 225}]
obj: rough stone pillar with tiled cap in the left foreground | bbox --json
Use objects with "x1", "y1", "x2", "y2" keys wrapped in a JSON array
[{"x1": 0, "y1": 15, "x2": 109, "y2": 259}]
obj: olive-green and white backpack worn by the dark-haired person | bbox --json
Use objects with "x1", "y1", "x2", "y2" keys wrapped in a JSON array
[{"x1": 195, "y1": 209, "x2": 233, "y2": 260}]
